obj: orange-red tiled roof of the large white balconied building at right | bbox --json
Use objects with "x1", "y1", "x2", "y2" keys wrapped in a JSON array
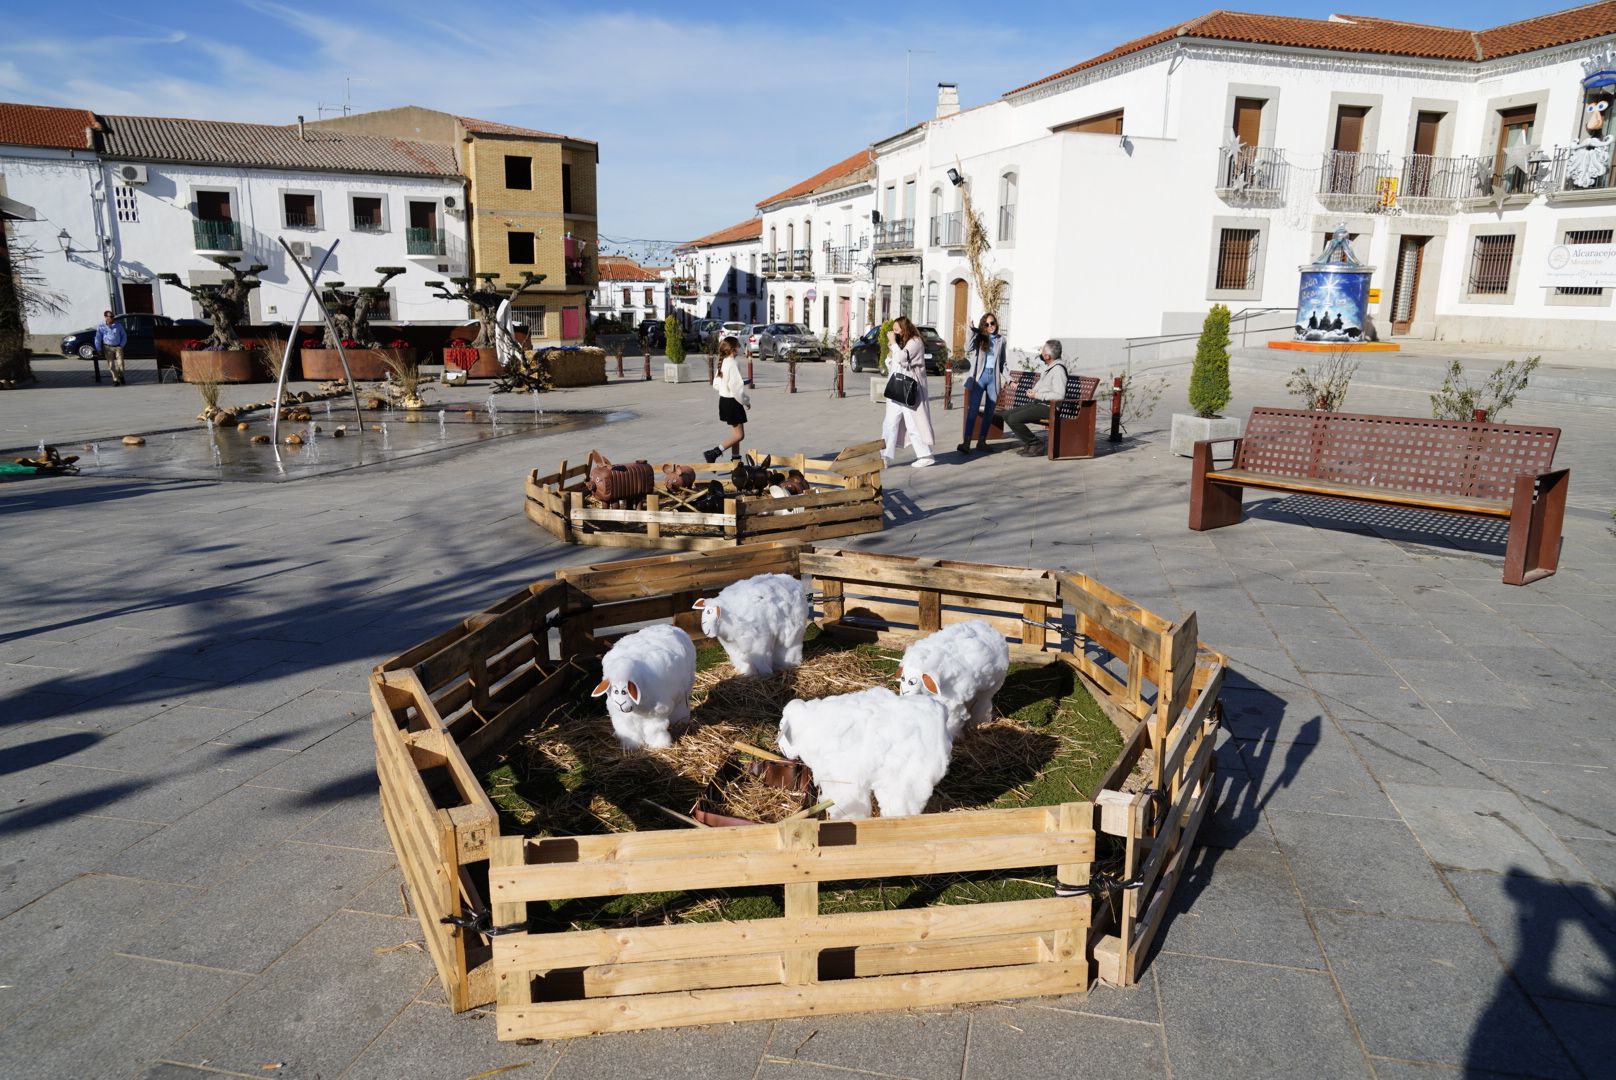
[{"x1": 1005, "y1": 0, "x2": 1616, "y2": 97}]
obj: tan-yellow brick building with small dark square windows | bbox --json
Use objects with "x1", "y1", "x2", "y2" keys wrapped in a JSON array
[{"x1": 310, "y1": 105, "x2": 600, "y2": 341}]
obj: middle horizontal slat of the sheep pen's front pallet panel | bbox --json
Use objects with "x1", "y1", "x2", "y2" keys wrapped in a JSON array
[{"x1": 494, "y1": 897, "x2": 1091, "y2": 972}]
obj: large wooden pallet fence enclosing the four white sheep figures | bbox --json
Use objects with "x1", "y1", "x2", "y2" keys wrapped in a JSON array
[{"x1": 372, "y1": 540, "x2": 1225, "y2": 1038}]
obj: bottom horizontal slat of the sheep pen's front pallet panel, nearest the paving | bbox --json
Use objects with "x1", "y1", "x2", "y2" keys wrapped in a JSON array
[{"x1": 498, "y1": 962, "x2": 1088, "y2": 1040}]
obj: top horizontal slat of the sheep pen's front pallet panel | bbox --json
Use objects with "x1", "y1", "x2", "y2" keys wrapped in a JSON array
[{"x1": 488, "y1": 834, "x2": 1094, "y2": 901}]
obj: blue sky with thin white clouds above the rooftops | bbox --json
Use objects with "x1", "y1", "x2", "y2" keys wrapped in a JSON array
[{"x1": 0, "y1": 0, "x2": 1574, "y2": 257}]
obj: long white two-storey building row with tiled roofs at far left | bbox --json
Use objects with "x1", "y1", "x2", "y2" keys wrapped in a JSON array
[{"x1": 0, "y1": 107, "x2": 467, "y2": 349}]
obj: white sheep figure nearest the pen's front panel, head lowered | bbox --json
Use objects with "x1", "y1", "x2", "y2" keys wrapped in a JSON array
[{"x1": 779, "y1": 686, "x2": 953, "y2": 818}]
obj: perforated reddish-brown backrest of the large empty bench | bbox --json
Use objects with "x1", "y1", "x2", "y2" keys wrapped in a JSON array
[{"x1": 1235, "y1": 409, "x2": 1559, "y2": 500}]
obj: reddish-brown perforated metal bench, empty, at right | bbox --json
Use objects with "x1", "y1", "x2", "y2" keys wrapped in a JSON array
[{"x1": 1189, "y1": 409, "x2": 1571, "y2": 585}]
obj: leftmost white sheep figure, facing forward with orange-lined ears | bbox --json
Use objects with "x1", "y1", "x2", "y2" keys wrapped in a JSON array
[{"x1": 590, "y1": 626, "x2": 696, "y2": 750}]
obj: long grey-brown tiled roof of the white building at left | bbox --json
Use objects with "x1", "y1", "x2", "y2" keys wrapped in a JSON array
[{"x1": 102, "y1": 116, "x2": 461, "y2": 176}]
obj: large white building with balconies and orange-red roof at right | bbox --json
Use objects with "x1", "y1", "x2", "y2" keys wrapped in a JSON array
[{"x1": 877, "y1": 3, "x2": 1616, "y2": 364}]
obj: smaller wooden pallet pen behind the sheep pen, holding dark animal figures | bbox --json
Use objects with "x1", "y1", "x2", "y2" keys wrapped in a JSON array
[{"x1": 522, "y1": 440, "x2": 882, "y2": 551}]
